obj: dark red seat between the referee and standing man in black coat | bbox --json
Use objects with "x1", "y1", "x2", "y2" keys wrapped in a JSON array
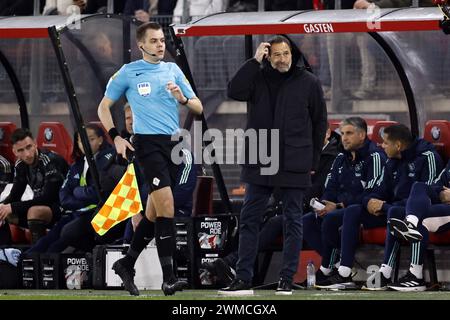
[{"x1": 192, "y1": 176, "x2": 214, "y2": 216}]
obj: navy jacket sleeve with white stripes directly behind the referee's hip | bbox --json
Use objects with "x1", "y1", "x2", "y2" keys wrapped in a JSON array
[{"x1": 173, "y1": 149, "x2": 199, "y2": 217}]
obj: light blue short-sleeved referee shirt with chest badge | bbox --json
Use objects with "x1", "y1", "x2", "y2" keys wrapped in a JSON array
[{"x1": 105, "y1": 59, "x2": 195, "y2": 135}]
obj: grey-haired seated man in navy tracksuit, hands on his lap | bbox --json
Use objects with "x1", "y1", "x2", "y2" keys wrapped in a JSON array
[{"x1": 303, "y1": 117, "x2": 386, "y2": 287}]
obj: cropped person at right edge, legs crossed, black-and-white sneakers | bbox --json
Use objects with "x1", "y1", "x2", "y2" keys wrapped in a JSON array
[{"x1": 389, "y1": 161, "x2": 450, "y2": 291}]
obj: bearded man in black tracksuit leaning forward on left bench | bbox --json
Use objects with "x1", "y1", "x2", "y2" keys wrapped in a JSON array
[{"x1": 0, "y1": 128, "x2": 68, "y2": 243}]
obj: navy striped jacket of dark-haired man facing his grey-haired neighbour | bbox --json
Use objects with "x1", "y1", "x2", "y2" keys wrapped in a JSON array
[{"x1": 364, "y1": 139, "x2": 443, "y2": 213}]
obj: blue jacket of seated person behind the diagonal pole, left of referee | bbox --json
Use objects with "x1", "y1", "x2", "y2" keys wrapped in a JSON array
[{"x1": 59, "y1": 146, "x2": 116, "y2": 211}]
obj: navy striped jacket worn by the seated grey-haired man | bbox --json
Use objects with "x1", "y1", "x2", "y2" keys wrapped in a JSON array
[{"x1": 321, "y1": 139, "x2": 386, "y2": 207}]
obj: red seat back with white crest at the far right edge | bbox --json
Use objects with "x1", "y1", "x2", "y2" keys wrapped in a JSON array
[{"x1": 424, "y1": 120, "x2": 450, "y2": 163}]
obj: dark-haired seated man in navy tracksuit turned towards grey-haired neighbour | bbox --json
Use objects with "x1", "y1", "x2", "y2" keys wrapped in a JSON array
[{"x1": 363, "y1": 124, "x2": 443, "y2": 290}]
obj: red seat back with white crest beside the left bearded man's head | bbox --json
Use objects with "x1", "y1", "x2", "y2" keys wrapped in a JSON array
[{"x1": 37, "y1": 122, "x2": 73, "y2": 164}]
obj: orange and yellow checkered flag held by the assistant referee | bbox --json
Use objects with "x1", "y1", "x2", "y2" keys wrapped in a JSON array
[{"x1": 91, "y1": 163, "x2": 142, "y2": 236}]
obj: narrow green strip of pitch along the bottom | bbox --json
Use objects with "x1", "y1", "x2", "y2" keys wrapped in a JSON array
[{"x1": 0, "y1": 290, "x2": 450, "y2": 300}]
